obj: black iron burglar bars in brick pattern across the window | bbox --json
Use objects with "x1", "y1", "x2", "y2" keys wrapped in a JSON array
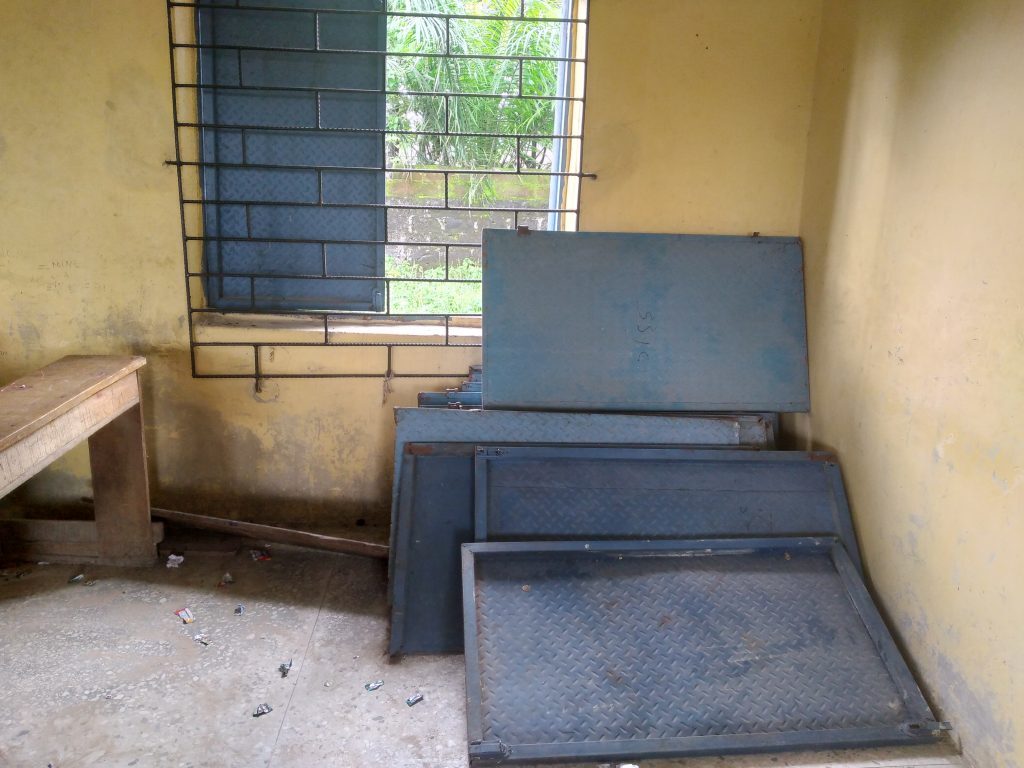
[{"x1": 167, "y1": 0, "x2": 593, "y2": 387}]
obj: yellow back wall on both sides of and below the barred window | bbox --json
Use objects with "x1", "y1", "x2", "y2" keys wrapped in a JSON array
[{"x1": 0, "y1": 0, "x2": 818, "y2": 523}]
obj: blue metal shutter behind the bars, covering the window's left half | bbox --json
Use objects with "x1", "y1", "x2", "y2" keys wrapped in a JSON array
[{"x1": 196, "y1": 0, "x2": 387, "y2": 311}]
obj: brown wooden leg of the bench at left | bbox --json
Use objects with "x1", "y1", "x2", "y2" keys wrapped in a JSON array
[{"x1": 89, "y1": 402, "x2": 157, "y2": 565}]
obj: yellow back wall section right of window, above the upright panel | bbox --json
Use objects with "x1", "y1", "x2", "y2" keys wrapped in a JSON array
[{"x1": 581, "y1": 0, "x2": 821, "y2": 234}]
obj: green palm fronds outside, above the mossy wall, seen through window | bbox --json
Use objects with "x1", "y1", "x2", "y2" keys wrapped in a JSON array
[{"x1": 387, "y1": 0, "x2": 562, "y2": 202}]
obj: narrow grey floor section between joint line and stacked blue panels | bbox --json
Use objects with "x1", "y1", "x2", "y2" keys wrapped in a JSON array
[{"x1": 271, "y1": 558, "x2": 467, "y2": 768}]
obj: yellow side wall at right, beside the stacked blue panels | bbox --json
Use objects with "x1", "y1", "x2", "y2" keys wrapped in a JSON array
[{"x1": 798, "y1": 0, "x2": 1024, "y2": 768}]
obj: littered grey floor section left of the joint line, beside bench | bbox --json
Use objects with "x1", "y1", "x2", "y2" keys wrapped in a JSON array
[{"x1": 0, "y1": 551, "x2": 333, "y2": 768}]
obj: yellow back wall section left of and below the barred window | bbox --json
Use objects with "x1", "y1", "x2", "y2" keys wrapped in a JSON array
[{"x1": 0, "y1": 0, "x2": 422, "y2": 523}]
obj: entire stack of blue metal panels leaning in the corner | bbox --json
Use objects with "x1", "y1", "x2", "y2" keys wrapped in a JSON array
[{"x1": 389, "y1": 230, "x2": 945, "y2": 765}]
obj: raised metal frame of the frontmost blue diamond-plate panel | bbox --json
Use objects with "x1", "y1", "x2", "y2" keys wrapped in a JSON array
[{"x1": 462, "y1": 538, "x2": 948, "y2": 765}]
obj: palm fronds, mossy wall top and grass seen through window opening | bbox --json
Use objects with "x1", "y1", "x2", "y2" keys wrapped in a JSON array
[{"x1": 386, "y1": 0, "x2": 564, "y2": 314}]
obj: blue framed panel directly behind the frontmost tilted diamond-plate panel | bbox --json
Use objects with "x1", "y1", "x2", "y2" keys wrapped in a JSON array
[{"x1": 474, "y1": 445, "x2": 860, "y2": 567}]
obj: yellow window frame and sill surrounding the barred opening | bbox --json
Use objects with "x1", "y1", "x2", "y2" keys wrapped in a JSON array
[{"x1": 167, "y1": 0, "x2": 593, "y2": 381}]
